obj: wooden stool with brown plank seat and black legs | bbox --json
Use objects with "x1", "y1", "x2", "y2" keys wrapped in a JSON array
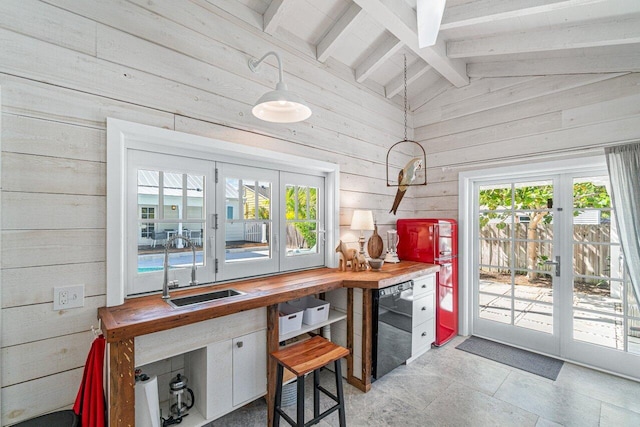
[{"x1": 271, "y1": 336, "x2": 349, "y2": 427}]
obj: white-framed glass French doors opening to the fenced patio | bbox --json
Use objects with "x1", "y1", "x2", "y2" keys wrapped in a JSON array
[{"x1": 467, "y1": 160, "x2": 640, "y2": 378}]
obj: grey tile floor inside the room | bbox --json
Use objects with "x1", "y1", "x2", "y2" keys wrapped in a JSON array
[{"x1": 208, "y1": 337, "x2": 640, "y2": 427}]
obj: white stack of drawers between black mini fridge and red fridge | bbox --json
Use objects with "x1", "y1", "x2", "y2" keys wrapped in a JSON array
[{"x1": 408, "y1": 274, "x2": 436, "y2": 362}]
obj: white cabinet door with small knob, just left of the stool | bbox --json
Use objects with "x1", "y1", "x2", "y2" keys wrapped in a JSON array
[{"x1": 233, "y1": 330, "x2": 267, "y2": 407}]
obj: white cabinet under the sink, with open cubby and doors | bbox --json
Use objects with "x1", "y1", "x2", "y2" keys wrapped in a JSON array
[{"x1": 136, "y1": 308, "x2": 267, "y2": 427}]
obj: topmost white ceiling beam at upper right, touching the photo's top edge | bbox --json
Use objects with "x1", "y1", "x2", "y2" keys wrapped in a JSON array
[{"x1": 440, "y1": 0, "x2": 606, "y2": 30}]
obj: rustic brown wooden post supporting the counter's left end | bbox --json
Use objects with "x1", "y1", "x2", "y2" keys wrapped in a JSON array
[{"x1": 109, "y1": 338, "x2": 136, "y2": 427}]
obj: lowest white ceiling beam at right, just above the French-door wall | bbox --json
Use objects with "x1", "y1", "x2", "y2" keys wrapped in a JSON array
[{"x1": 467, "y1": 54, "x2": 640, "y2": 77}]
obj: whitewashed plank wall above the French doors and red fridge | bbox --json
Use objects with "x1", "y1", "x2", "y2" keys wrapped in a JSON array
[{"x1": 413, "y1": 73, "x2": 640, "y2": 218}]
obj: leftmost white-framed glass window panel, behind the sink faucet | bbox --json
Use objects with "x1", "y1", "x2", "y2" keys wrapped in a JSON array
[{"x1": 127, "y1": 150, "x2": 215, "y2": 295}]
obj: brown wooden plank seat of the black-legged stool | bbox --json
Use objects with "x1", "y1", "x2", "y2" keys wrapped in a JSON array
[{"x1": 271, "y1": 335, "x2": 349, "y2": 377}]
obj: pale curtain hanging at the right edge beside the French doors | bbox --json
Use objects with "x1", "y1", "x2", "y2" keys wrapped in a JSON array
[{"x1": 605, "y1": 143, "x2": 640, "y2": 305}]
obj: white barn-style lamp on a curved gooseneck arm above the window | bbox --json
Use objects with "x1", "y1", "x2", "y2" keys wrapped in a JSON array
[{"x1": 249, "y1": 51, "x2": 311, "y2": 123}]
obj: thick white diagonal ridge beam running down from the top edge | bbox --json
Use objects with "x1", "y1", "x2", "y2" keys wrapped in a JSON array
[{"x1": 354, "y1": 0, "x2": 469, "y2": 87}]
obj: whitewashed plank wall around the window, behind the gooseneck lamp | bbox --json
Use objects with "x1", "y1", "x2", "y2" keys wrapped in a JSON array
[{"x1": 0, "y1": 0, "x2": 413, "y2": 425}]
